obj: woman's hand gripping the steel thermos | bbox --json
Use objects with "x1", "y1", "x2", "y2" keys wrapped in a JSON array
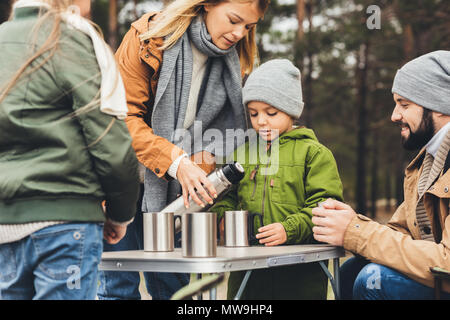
[{"x1": 177, "y1": 158, "x2": 217, "y2": 208}]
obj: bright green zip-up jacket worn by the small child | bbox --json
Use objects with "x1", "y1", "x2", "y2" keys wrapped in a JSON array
[{"x1": 212, "y1": 128, "x2": 343, "y2": 244}]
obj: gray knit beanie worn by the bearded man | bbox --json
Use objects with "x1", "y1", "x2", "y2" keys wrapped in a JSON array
[{"x1": 392, "y1": 50, "x2": 450, "y2": 115}]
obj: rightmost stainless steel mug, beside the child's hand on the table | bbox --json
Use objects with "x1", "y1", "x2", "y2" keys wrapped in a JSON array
[{"x1": 224, "y1": 211, "x2": 263, "y2": 247}]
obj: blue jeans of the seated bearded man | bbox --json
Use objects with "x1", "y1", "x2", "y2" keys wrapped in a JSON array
[{"x1": 339, "y1": 257, "x2": 450, "y2": 300}]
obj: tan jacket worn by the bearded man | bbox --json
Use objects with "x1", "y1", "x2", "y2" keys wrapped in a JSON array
[{"x1": 344, "y1": 149, "x2": 450, "y2": 292}]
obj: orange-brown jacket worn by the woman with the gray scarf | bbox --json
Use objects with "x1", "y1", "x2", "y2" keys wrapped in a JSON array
[{"x1": 116, "y1": 13, "x2": 215, "y2": 178}]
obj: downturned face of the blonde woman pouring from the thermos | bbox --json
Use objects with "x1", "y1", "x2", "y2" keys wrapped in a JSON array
[{"x1": 205, "y1": 1, "x2": 262, "y2": 50}]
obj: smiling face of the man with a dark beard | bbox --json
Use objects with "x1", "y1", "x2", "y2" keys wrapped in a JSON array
[{"x1": 391, "y1": 93, "x2": 435, "y2": 150}]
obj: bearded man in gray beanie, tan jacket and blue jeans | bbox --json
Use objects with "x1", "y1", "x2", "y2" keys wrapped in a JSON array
[{"x1": 312, "y1": 51, "x2": 450, "y2": 300}]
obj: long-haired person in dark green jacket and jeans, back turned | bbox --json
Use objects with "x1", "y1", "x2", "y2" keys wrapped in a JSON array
[{"x1": 0, "y1": 0, "x2": 139, "y2": 300}]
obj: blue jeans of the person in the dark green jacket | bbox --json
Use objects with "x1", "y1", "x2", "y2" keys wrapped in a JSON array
[{"x1": 0, "y1": 223, "x2": 103, "y2": 300}]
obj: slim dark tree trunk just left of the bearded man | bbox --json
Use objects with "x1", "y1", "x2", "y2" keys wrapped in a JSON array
[{"x1": 356, "y1": 41, "x2": 369, "y2": 214}]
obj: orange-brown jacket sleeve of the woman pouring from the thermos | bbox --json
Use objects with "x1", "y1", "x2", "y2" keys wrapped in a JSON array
[{"x1": 116, "y1": 27, "x2": 184, "y2": 178}]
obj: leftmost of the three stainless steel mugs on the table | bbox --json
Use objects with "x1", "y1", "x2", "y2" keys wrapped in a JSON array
[{"x1": 143, "y1": 212, "x2": 176, "y2": 252}]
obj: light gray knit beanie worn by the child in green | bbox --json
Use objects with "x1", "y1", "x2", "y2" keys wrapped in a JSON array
[{"x1": 242, "y1": 59, "x2": 303, "y2": 119}]
